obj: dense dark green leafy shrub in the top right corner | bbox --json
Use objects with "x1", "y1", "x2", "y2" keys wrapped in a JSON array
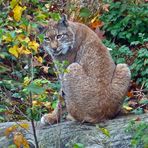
[{"x1": 101, "y1": 1, "x2": 148, "y2": 44}]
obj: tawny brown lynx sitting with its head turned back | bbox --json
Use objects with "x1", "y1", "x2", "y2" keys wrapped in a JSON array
[{"x1": 41, "y1": 15, "x2": 131, "y2": 124}]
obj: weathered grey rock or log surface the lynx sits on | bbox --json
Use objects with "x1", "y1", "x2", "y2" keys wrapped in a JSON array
[{"x1": 0, "y1": 113, "x2": 148, "y2": 148}]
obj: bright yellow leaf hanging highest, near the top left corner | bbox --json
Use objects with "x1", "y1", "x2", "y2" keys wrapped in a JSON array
[{"x1": 13, "y1": 4, "x2": 26, "y2": 22}]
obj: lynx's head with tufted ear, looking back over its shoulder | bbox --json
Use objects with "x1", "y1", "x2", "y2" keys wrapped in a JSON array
[{"x1": 43, "y1": 15, "x2": 75, "y2": 56}]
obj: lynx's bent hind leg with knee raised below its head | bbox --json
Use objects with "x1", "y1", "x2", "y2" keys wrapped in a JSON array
[{"x1": 62, "y1": 63, "x2": 98, "y2": 122}]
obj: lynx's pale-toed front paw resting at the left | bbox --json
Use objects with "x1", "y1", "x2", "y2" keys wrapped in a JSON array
[{"x1": 41, "y1": 113, "x2": 58, "y2": 125}]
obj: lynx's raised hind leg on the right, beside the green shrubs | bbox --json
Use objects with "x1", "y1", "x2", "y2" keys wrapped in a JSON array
[{"x1": 111, "y1": 64, "x2": 131, "y2": 102}]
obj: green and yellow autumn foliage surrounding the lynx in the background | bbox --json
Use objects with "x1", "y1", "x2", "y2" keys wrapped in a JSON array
[{"x1": 0, "y1": 0, "x2": 148, "y2": 147}]
